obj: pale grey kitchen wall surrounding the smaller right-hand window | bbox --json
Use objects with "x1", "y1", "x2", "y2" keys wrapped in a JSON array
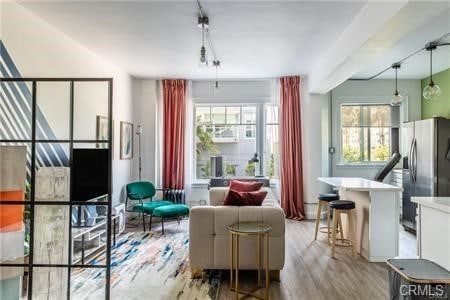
[{"x1": 331, "y1": 79, "x2": 422, "y2": 179}]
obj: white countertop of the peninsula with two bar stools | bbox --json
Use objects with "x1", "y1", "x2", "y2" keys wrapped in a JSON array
[{"x1": 319, "y1": 177, "x2": 403, "y2": 192}]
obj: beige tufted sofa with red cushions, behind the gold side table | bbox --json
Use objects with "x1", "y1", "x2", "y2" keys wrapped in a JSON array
[{"x1": 189, "y1": 187, "x2": 285, "y2": 279}]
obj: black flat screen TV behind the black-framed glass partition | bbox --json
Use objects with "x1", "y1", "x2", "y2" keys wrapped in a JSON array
[{"x1": 71, "y1": 148, "x2": 110, "y2": 201}]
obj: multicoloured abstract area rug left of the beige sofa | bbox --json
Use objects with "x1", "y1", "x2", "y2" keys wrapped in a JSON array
[{"x1": 71, "y1": 229, "x2": 221, "y2": 300}]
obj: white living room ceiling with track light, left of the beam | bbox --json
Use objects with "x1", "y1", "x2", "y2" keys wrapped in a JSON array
[{"x1": 19, "y1": 1, "x2": 366, "y2": 79}]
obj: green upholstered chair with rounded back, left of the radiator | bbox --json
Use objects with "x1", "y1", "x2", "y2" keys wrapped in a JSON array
[{"x1": 125, "y1": 181, "x2": 175, "y2": 231}]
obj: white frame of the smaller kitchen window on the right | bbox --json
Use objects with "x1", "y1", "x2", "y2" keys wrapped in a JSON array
[{"x1": 337, "y1": 102, "x2": 393, "y2": 167}]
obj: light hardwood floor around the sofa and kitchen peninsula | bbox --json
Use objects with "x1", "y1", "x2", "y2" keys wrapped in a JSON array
[{"x1": 127, "y1": 220, "x2": 415, "y2": 300}]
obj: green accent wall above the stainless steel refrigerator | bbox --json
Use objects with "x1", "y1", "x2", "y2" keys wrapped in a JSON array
[{"x1": 422, "y1": 68, "x2": 450, "y2": 119}]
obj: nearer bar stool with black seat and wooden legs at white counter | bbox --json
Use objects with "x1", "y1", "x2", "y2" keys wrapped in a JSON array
[{"x1": 329, "y1": 200, "x2": 356, "y2": 258}]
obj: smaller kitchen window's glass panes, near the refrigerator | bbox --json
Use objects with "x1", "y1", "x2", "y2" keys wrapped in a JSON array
[{"x1": 341, "y1": 104, "x2": 391, "y2": 164}]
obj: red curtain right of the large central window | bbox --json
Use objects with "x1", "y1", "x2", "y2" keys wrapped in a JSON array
[{"x1": 280, "y1": 76, "x2": 305, "y2": 220}]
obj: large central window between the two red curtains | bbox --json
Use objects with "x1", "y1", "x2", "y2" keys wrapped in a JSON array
[{"x1": 195, "y1": 104, "x2": 278, "y2": 179}]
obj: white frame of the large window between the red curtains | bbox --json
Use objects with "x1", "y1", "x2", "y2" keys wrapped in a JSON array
[{"x1": 192, "y1": 103, "x2": 279, "y2": 180}]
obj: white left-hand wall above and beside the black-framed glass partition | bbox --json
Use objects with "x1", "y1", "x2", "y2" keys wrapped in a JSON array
[{"x1": 0, "y1": 1, "x2": 133, "y2": 203}]
